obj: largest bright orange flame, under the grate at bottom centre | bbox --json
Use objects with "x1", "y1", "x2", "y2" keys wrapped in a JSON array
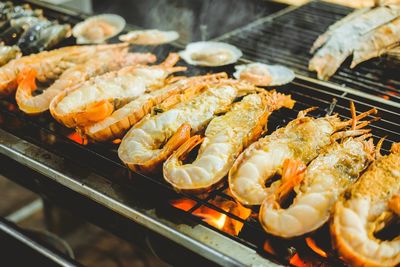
[{"x1": 171, "y1": 198, "x2": 251, "y2": 235}]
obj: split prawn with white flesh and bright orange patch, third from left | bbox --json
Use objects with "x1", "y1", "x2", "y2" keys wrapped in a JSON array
[{"x1": 50, "y1": 54, "x2": 186, "y2": 127}]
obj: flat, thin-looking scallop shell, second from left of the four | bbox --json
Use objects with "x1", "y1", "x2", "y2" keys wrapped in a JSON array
[{"x1": 119, "y1": 30, "x2": 179, "y2": 45}]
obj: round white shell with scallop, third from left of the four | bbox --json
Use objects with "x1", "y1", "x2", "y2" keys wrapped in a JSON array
[{"x1": 179, "y1": 42, "x2": 243, "y2": 67}]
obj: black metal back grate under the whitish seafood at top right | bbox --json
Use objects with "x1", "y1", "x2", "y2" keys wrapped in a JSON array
[{"x1": 217, "y1": 1, "x2": 400, "y2": 102}]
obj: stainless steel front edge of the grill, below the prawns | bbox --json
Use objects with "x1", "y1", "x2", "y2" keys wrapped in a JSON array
[{"x1": 0, "y1": 129, "x2": 278, "y2": 266}]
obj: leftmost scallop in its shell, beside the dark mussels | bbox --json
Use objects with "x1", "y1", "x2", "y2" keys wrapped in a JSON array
[{"x1": 72, "y1": 14, "x2": 126, "y2": 44}]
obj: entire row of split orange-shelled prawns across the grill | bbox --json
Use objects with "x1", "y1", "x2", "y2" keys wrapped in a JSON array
[{"x1": 0, "y1": 36, "x2": 400, "y2": 266}]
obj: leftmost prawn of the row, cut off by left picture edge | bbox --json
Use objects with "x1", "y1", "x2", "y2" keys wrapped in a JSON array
[{"x1": 0, "y1": 43, "x2": 127, "y2": 96}]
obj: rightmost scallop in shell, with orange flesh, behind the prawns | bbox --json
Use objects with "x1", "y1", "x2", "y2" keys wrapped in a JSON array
[{"x1": 233, "y1": 63, "x2": 295, "y2": 86}]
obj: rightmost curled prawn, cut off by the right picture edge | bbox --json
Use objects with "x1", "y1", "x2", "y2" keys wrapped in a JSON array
[{"x1": 331, "y1": 143, "x2": 400, "y2": 266}]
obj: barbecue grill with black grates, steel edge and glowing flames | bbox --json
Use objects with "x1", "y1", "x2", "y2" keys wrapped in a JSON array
[{"x1": 0, "y1": 1, "x2": 400, "y2": 266}]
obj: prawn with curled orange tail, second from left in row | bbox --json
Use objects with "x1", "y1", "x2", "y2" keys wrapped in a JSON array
[{"x1": 15, "y1": 47, "x2": 156, "y2": 114}]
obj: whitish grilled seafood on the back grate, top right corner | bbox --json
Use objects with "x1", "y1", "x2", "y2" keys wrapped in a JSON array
[{"x1": 309, "y1": 1, "x2": 400, "y2": 79}]
